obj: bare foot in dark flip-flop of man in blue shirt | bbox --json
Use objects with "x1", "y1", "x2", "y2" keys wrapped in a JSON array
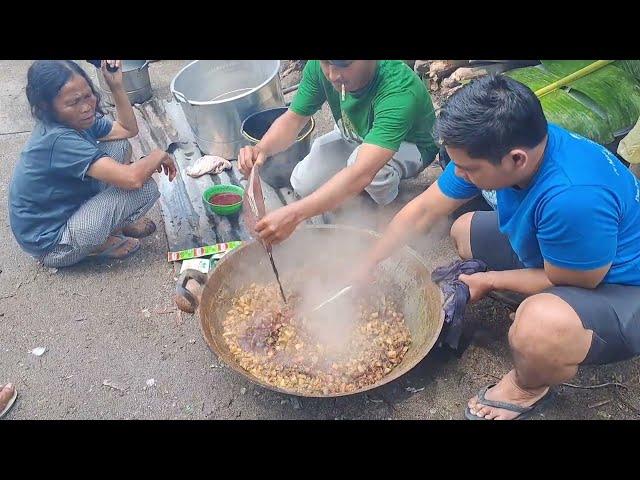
[{"x1": 468, "y1": 370, "x2": 549, "y2": 420}]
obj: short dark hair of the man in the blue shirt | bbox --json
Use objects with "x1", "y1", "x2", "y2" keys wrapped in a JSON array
[{"x1": 435, "y1": 75, "x2": 547, "y2": 164}]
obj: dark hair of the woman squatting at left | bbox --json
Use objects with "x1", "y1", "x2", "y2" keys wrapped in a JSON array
[{"x1": 26, "y1": 60, "x2": 104, "y2": 123}]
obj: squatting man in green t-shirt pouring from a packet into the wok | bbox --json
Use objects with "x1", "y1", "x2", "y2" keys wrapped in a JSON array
[{"x1": 238, "y1": 60, "x2": 438, "y2": 243}]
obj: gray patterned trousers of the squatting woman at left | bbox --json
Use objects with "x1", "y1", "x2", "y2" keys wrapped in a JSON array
[{"x1": 40, "y1": 140, "x2": 160, "y2": 268}]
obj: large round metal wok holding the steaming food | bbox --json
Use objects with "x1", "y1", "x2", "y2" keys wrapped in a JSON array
[{"x1": 179, "y1": 225, "x2": 444, "y2": 397}]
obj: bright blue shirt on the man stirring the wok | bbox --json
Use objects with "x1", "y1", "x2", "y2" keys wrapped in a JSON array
[{"x1": 438, "y1": 124, "x2": 640, "y2": 285}]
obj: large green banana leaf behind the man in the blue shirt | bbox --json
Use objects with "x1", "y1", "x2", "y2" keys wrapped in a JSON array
[{"x1": 505, "y1": 60, "x2": 640, "y2": 145}]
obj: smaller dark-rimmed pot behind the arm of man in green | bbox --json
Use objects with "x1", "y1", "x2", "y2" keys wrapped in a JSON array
[{"x1": 242, "y1": 107, "x2": 316, "y2": 188}]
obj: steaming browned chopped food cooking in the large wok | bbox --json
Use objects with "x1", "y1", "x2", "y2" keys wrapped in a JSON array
[{"x1": 223, "y1": 282, "x2": 411, "y2": 395}]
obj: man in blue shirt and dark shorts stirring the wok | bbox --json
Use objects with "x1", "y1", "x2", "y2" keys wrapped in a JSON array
[{"x1": 358, "y1": 76, "x2": 640, "y2": 420}]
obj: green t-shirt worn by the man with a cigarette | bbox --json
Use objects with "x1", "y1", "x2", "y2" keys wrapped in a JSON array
[{"x1": 290, "y1": 60, "x2": 438, "y2": 165}]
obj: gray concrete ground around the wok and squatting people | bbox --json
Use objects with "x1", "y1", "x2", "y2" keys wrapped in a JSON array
[{"x1": 0, "y1": 60, "x2": 640, "y2": 419}]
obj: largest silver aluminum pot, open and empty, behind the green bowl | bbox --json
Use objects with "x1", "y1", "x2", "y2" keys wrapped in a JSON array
[{"x1": 171, "y1": 60, "x2": 284, "y2": 159}]
